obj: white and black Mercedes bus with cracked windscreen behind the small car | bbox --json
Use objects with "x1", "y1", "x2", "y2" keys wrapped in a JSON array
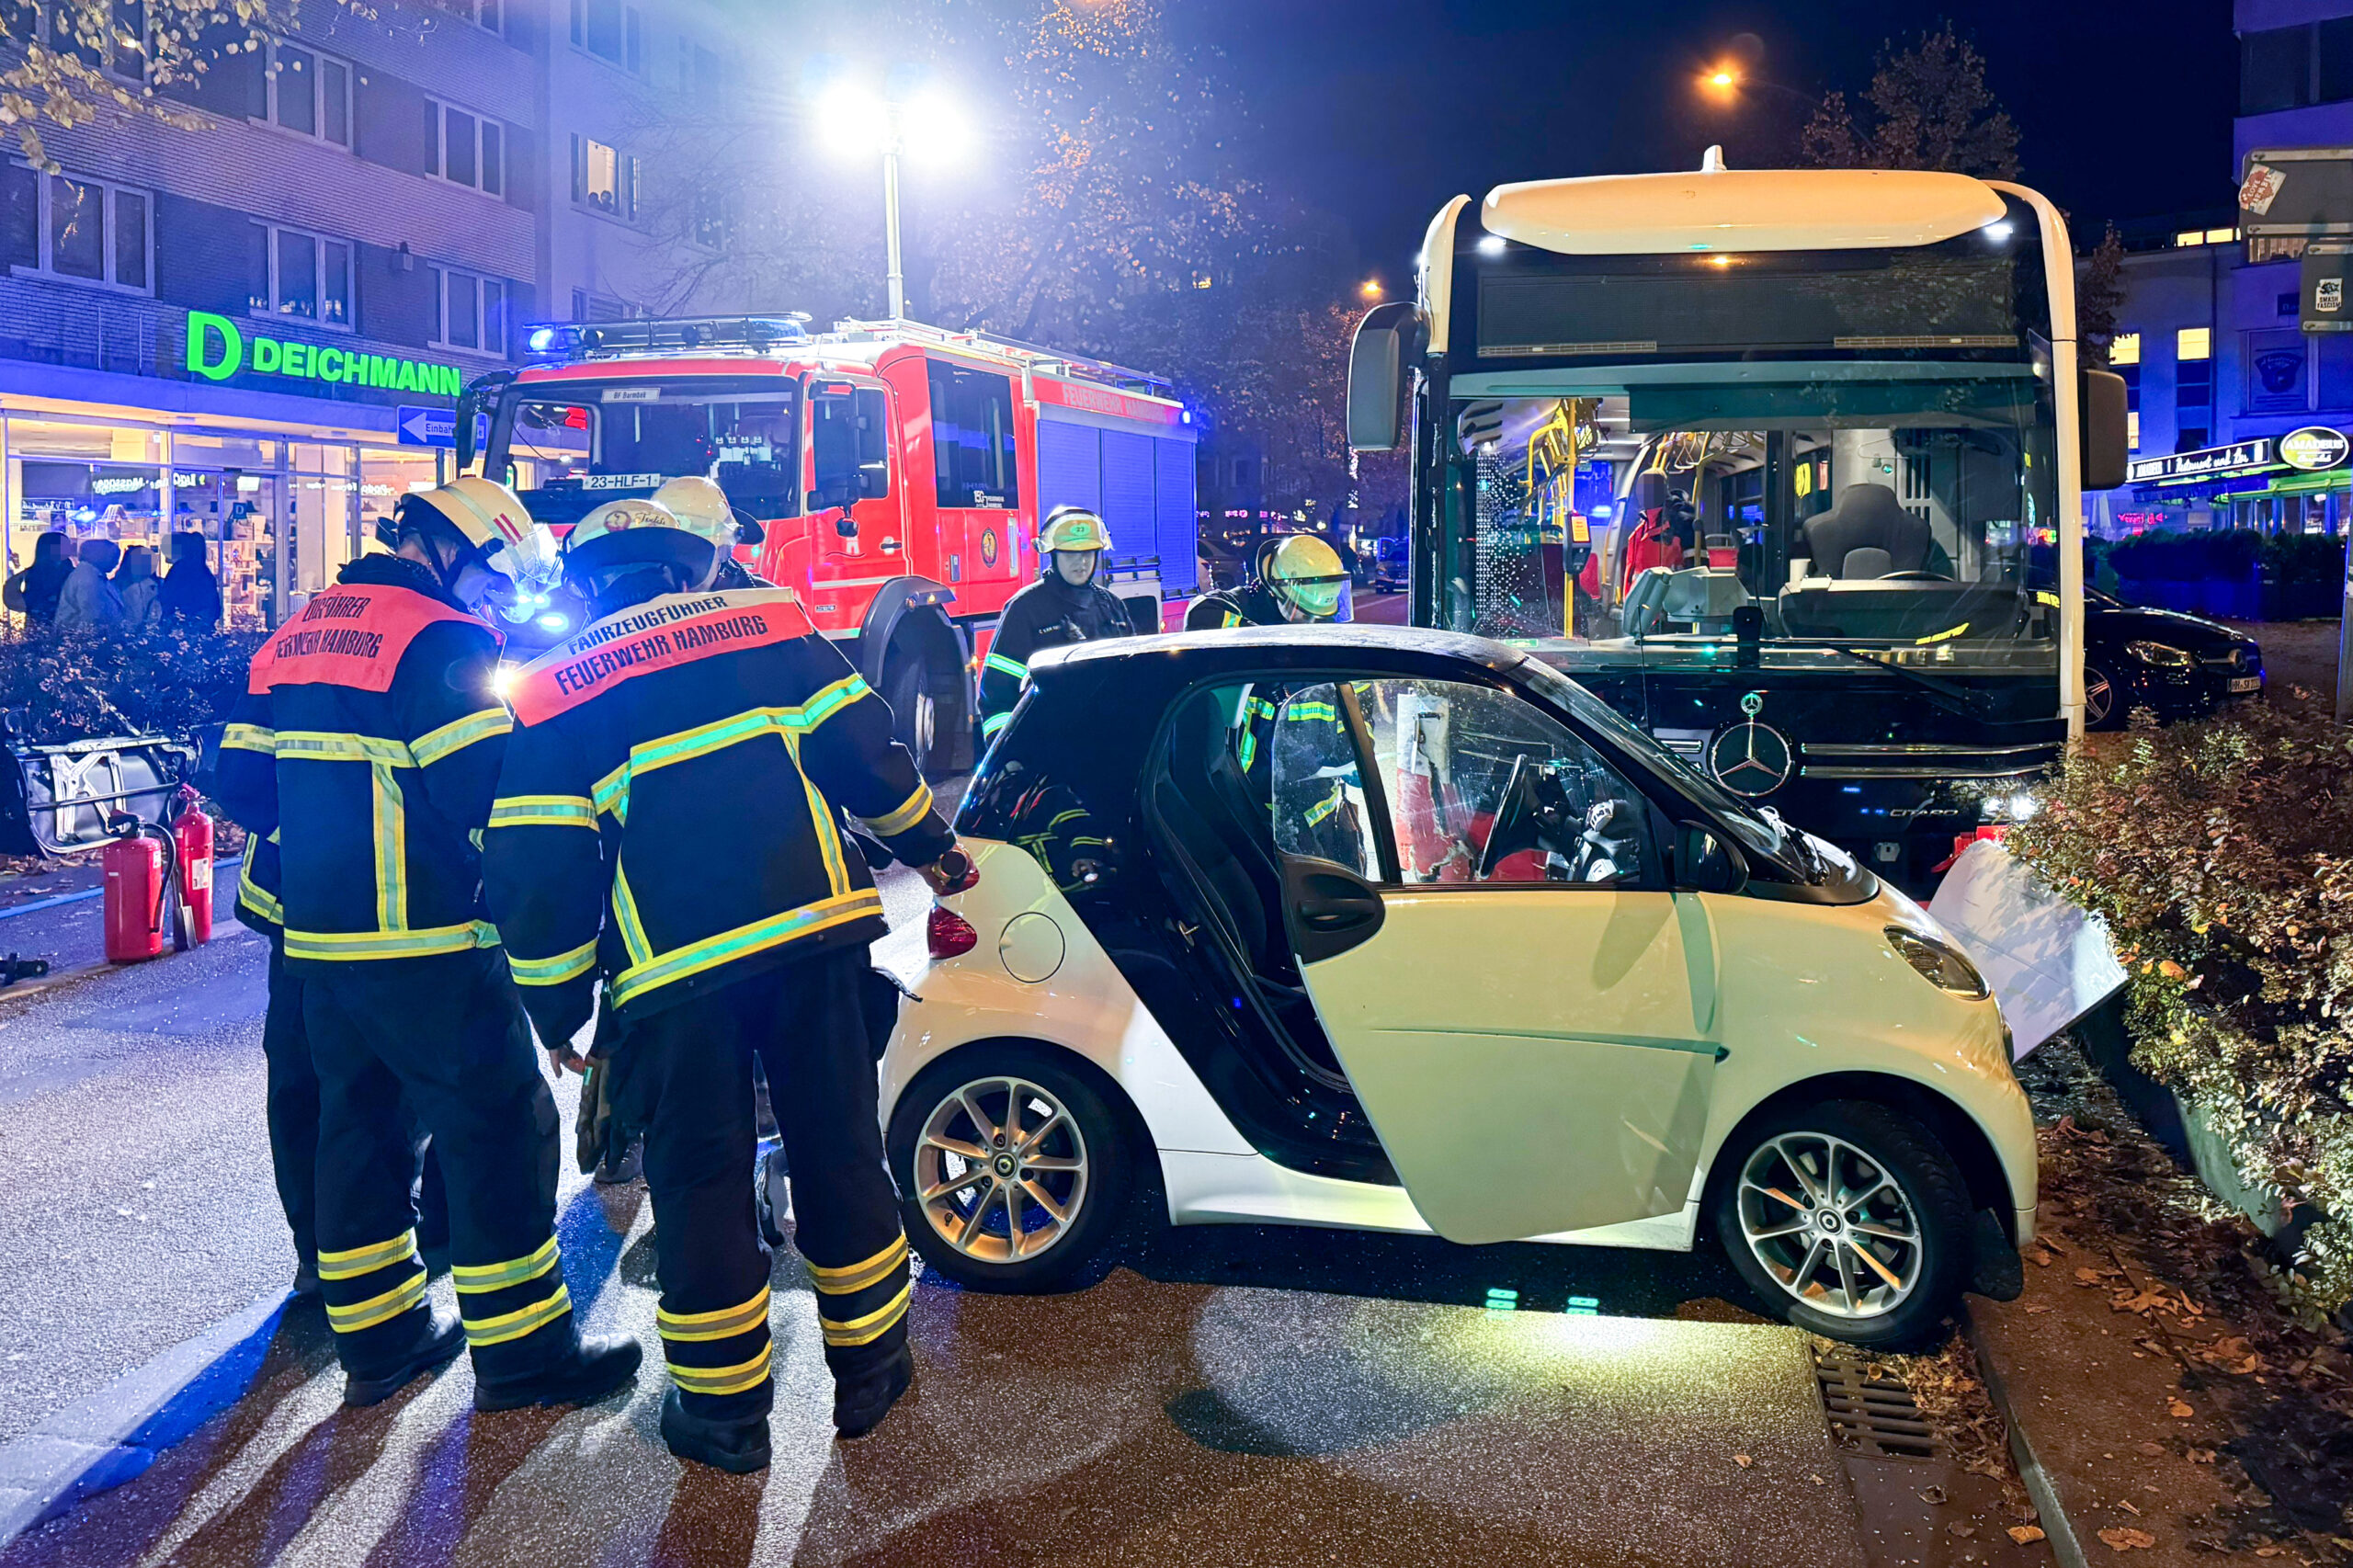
[{"x1": 1348, "y1": 161, "x2": 2125, "y2": 888}]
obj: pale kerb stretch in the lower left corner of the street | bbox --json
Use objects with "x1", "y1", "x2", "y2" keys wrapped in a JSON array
[{"x1": 0, "y1": 1290, "x2": 294, "y2": 1547}]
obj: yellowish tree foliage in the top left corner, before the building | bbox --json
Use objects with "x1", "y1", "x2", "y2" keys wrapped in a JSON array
[{"x1": 0, "y1": 0, "x2": 308, "y2": 175}]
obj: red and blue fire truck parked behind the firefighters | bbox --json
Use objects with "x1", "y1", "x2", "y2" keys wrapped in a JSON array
[{"x1": 457, "y1": 315, "x2": 1200, "y2": 777}]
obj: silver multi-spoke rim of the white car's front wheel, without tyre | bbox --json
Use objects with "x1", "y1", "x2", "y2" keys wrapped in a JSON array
[{"x1": 1736, "y1": 1131, "x2": 1925, "y2": 1318}]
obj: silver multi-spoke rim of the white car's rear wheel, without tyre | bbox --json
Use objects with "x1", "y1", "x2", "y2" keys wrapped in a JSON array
[{"x1": 911, "y1": 1076, "x2": 1087, "y2": 1265}]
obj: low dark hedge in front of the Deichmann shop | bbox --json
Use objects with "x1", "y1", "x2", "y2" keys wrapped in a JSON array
[{"x1": 0, "y1": 626, "x2": 261, "y2": 742}]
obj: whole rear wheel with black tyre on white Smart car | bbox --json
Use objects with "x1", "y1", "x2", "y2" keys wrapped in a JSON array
[{"x1": 885, "y1": 1045, "x2": 1136, "y2": 1295}]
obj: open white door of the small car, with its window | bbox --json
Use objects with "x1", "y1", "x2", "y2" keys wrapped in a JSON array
[{"x1": 1270, "y1": 678, "x2": 1718, "y2": 1244}]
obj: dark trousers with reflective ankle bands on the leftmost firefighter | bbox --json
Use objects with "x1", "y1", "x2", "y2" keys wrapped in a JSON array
[{"x1": 299, "y1": 949, "x2": 576, "y2": 1382}]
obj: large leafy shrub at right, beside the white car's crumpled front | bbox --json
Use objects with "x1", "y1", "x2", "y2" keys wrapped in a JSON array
[{"x1": 2009, "y1": 701, "x2": 2353, "y2": 1313}]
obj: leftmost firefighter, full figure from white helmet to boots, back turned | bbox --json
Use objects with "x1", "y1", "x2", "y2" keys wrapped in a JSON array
[{"x1": 219, "y1": 475, "x2": 640, "y2": 1410}]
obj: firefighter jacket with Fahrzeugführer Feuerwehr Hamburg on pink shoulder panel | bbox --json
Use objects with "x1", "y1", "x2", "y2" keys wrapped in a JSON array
[{"x1": 483, "y1": 588, "x2": 955, "y2": 1039}]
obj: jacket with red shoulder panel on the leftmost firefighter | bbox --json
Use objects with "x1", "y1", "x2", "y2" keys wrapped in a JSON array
[{"x1": 219, "y1": 556, "x2": 513, "y2": 965}]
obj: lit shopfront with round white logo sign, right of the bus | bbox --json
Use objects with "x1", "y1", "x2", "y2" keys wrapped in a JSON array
[{"x1": 2109, "y1": 424, "x2": 2353, "y2": 534}]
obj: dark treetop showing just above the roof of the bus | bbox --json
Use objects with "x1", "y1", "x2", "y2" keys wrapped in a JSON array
[{"x1": 1798, "y1": 24, "x2": 2018, "y2": 179}]
